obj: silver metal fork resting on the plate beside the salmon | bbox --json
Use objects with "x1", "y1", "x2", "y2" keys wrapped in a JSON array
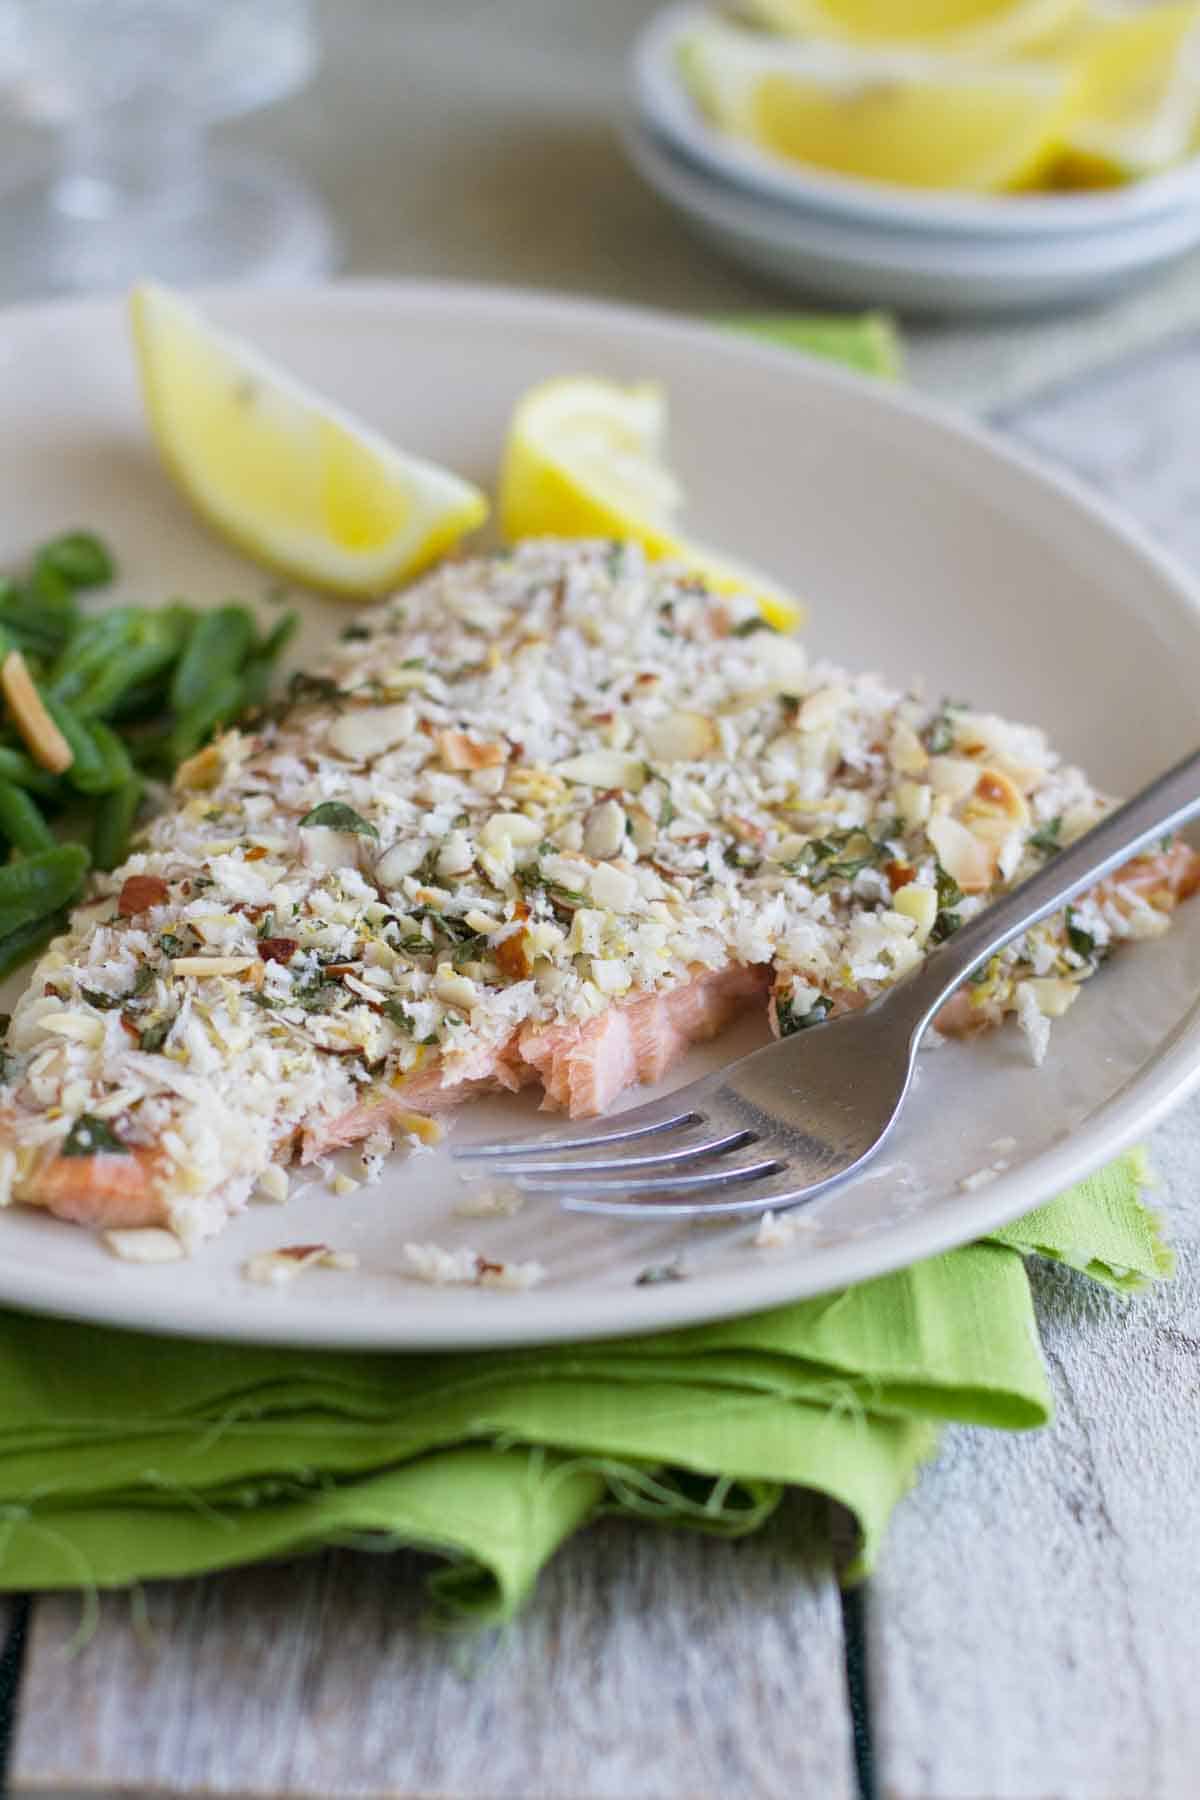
[{"x1": 455, "y1": 751, "x2": 1200, "y2": 1219}]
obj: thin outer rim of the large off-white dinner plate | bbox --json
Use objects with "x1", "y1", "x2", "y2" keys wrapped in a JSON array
[{"x1": 0, "y1": 281, "x2": 1200, "y2": 1352}]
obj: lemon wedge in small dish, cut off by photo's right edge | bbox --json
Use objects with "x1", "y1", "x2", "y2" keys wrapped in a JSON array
[{"x1": 1052, "y1": 5, "x2": 1200, "y2": 187}]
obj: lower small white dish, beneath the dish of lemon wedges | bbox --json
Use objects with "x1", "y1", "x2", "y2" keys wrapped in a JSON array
[{"x1": 624, "y1": 124, "x2": 1200, "y2": 317}]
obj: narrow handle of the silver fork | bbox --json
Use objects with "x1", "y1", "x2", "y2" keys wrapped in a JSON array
[{"x1": 896, "y1": 751, "x2": 1200, "y2": 1037}]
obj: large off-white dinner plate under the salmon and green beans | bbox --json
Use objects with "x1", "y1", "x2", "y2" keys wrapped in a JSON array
[{"x1": 0, "y1": 284, "x2": 1200, "y2": 1348}]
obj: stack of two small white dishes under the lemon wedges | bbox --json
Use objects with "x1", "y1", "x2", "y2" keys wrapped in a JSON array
[{"x1": 626, "y1": 4, "x2": 1200, "y2": 313}]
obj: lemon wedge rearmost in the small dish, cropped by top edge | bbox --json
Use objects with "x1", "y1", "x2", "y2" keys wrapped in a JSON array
[{"x1": 741, "y1": 0, "x2": 1087, "y2": 56}]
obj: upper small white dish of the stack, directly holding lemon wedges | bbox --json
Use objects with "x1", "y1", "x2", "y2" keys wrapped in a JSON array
[{"x1": 630, "y1": 0, "x2": 1200, "y2": 239}]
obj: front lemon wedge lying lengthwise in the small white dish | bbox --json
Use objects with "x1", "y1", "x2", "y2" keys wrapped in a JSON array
[{"x1": 680, "y1": 25, "x2": 1079, "y2": 193}]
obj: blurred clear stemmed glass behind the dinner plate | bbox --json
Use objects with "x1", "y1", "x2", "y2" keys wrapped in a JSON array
[{"x1": 0, "y1": 0, "x2": 336, "y2": 299}]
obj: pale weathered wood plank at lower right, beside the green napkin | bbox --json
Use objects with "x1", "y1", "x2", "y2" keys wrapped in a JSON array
[{"x1": 867, "y1": 1103, "x2": 1200, "y2": 1800}]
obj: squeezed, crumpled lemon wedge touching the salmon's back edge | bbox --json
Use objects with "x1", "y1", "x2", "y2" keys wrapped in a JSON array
[{"x1": 500, "y1": 376, "x2": 804, "y2": 632}]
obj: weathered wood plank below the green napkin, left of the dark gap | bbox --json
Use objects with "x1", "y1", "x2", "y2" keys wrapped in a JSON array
[{"x1": 11, "y1": 1499, "x2": 855, "y2": 1800}]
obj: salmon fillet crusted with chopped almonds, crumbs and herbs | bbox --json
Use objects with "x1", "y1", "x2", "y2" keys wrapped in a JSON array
[{"x1": 0, "y1": 540, "x2": 1198, "y2": 1244}]
